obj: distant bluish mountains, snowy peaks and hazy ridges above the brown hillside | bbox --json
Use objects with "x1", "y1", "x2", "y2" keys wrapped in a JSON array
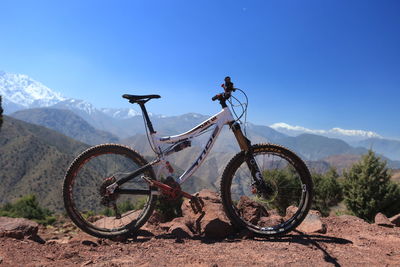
[{"x1": 0, "y1": 71, "x2": 400, "y2": 160}]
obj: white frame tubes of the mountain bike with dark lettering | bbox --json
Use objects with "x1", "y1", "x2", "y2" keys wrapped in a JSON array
[{"x1": 146, "y1": 107, "x2": 234, "y2": 184}]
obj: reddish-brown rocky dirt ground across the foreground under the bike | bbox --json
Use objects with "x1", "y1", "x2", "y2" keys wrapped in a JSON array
[{"x1": 0, "y1": 191, "x2": 400, "y2": 266}]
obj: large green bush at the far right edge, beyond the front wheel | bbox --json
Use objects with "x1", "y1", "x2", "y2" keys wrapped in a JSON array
[{"x1": 344, "y1": 150, "x2": 400, "y2": 222}]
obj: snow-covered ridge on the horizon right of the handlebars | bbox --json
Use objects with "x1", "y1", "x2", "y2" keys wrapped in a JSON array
[{"x1": 270, "y1": 122, "x2": 382, "y2": 142}]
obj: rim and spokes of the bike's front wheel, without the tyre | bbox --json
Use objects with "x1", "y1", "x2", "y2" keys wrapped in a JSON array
[{"x1": 229, "y1": 151, "x2": 307, "y2": 234}]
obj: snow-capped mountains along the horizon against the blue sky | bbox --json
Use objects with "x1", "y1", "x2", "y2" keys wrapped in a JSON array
[{"x1": 0, "y1": 71, "x2": 400, "y2": 162}]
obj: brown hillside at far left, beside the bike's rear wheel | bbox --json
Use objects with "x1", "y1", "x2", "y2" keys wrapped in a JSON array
[{"x1": 0, "y1": 116, "x2": 88, "y2": 210}]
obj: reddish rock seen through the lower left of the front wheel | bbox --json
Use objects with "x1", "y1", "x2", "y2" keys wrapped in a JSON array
[{"x1": 237, "y1": 196, "x2": 268, "y2": 225}]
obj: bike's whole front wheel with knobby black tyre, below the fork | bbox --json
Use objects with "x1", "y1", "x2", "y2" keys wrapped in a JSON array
[{"x1": 221, "y1": 144, "x2": 313, "y2": 236}]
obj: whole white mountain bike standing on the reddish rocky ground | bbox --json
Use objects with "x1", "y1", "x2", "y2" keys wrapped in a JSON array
[{"x1": 63, "y1": 77, "x2": 313, "y2": 238}]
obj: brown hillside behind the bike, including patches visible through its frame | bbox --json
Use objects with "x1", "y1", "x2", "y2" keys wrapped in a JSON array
[{"x1": 0, "y1": 116, "x2": 233, "y2": 211}]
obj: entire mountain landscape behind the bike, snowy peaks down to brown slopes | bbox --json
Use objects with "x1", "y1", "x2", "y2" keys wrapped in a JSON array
[{"x1": 0, "y1": 72, "x2": 400, "y2": 213}]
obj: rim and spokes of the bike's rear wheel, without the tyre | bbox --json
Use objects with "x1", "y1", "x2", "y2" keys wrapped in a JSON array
[{"x1": 68, "y1": 152, "x2": 151, "y2": 232}]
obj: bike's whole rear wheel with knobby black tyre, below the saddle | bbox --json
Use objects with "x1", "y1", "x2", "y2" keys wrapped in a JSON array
[{"x1": 63, "y1": 144, "x2": 156, "y2": 238}]
